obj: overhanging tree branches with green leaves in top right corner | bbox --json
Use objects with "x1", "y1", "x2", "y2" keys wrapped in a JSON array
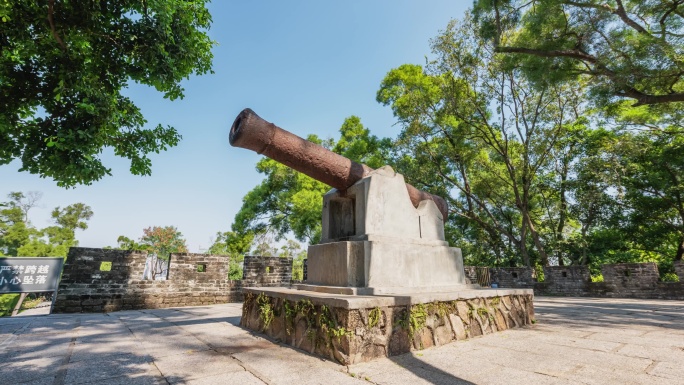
[{"x1": 474, "y1": 0, "x2": 684, "y2": 108}]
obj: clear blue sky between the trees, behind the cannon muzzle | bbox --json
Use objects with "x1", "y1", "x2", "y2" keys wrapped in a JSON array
[{"x1": 0, "y1": 0, "x2": 472, "y2": 252}]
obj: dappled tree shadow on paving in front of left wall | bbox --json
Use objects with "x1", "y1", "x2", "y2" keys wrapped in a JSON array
[{"x1": 0, "y1": 311, "x2": 246, "y2": 385}]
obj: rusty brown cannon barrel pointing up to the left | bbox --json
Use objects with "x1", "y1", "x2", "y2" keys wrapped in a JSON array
[{"x1": 229, "y1": 108, "x2": 447, "y2": 221}]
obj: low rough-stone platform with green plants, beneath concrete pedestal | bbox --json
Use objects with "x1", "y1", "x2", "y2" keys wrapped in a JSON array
[{"x1": 240, "y1": 288, "x2": 534, "y2": 365}]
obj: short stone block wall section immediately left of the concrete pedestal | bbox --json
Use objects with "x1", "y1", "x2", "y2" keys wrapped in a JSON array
[{"x1": 242, "y1": 255, "x2": 292, "y2": 287}]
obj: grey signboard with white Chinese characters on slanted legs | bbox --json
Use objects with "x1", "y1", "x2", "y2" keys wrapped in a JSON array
[{"x1": 0, "y1": 257, "x2": 64, "y2": 315}]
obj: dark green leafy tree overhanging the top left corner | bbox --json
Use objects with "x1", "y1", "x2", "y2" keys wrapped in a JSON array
[{"x1": 0, "y1": 0, "x2": 214, "y2": 187}]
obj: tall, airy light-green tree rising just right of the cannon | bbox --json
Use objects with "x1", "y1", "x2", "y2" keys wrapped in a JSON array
[{"x1": 377, "y1": 18, "x2": 585, "y2": 266}]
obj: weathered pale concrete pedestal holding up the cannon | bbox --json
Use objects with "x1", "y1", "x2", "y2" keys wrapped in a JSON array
[{"x1": 307, "y1": 166, "x2": 465, "y2": 294}]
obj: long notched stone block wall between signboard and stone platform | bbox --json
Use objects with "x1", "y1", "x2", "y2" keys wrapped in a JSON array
[{"x1": 54, "y1": 247, "x2": 242, "y2": 313}]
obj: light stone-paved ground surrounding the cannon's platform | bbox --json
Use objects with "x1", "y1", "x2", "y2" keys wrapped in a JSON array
[{"x1": 0, "y1": 297, "x2": 684, "y2": 385}]
